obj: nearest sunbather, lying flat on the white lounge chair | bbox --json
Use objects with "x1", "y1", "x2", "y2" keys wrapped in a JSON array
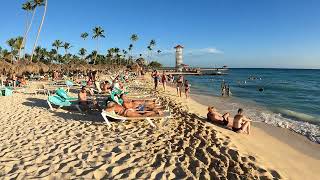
[{"x1": 105, "y1": 102, "x2": 163, "y2": 117}]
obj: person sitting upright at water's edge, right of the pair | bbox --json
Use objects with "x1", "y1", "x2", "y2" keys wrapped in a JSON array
[{"x1": 232, "y1": 108, "x2": 251, "y2": 135}]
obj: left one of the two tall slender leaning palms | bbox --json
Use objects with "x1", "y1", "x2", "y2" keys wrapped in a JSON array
[{"x1": 18, "y1": 1, "x2": 36, "y2": 61}]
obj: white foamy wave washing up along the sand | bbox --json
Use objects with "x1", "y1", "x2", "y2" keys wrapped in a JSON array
[{"x1": 192, "y1": 95, "x2": 320, "y2": 144}]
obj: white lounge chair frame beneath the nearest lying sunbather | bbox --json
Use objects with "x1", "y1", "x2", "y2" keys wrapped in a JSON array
[{"x1": 101, "y1": 110, "x2": 171, "y2": 128}]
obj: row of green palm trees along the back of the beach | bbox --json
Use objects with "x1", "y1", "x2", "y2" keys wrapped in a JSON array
[{"x1": 0, "y1": 0, "x2": 162, "y2": 68}]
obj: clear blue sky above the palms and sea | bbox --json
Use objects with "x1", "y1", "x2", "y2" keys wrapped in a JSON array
[{"x1": 0, "y1": 0, "x2": 320, "y2": 68}]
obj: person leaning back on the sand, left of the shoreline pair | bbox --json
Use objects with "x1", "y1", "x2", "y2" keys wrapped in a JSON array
[{"x1": 207, "y1": 106, "x2": 232, "y2": 126}]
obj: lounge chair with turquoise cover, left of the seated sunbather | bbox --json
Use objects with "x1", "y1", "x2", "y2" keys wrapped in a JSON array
[{"x1": 47, "y1": 95, "x2": 82, "y2": 113}]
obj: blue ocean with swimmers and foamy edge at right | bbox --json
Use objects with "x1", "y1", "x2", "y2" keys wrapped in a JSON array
[{"x1": 185, "y1": 69, "x2": 320, "y2": 143}]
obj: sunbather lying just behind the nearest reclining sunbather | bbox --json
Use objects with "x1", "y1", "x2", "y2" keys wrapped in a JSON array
[{"x1": 120, "y1": 94, "x2": 156, "y2": 111}]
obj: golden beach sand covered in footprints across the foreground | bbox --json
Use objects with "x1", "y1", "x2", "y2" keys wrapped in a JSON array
[{"x1": 0, "y1": 81, "x2": 320, "y2": 179}]
